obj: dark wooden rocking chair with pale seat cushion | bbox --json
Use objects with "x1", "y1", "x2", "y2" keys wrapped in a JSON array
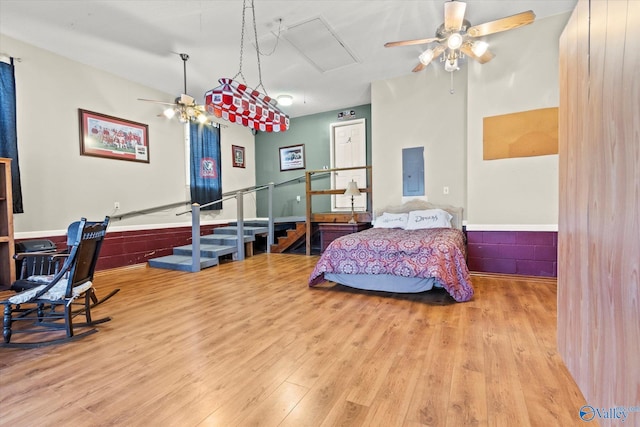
[{"x1": 1, "y1": 217, "x2": 117, "y2": 347}]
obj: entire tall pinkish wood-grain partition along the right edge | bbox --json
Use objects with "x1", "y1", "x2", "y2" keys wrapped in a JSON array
[{"x1": 558, "y1": 0, "x2": 640, "y2": 425}]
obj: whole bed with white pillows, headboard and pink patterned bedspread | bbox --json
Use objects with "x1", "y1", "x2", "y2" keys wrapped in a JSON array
[{"x1": 309, "y1": 200, "x2": 473, "y2": 302}]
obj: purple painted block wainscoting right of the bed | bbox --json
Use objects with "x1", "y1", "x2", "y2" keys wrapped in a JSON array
[{"x1": 467, "y1": 231, "x2": 558, "y2": 277}]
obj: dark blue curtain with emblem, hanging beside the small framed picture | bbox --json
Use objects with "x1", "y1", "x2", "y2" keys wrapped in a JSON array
[{"x1": 189, "y1": 123, "x2": 222, "y2": 210}]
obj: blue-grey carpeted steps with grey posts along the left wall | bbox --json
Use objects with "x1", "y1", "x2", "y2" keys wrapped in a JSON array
[{"x1": 148, "y1": 226, "x2": 269, "y2": 271}]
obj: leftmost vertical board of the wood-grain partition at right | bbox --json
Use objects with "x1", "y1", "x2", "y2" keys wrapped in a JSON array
[{"x1": 558, "y1": 3, "x2": 590, "y2": 392}]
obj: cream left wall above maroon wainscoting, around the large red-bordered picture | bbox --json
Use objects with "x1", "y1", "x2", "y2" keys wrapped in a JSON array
[{"x1": 0, "y1": 35, "x2": 255, "y2": 238}]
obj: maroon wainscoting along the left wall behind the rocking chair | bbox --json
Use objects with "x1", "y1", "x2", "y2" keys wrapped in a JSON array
[{"x1": 16, "y1": 224, "x2": 226, "y2": 270}]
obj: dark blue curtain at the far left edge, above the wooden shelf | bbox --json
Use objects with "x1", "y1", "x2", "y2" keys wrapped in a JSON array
[{"x1": 0, "y1": 58, "x2": 24, "y2": 213}]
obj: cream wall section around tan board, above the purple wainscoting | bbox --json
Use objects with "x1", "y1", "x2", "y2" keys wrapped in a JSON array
[{"x1": 467, "y1": 14, "x2": 569, "y2": 231}]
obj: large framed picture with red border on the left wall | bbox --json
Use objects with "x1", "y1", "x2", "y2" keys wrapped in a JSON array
[{"x1": 78, "y1": 109, "x2": 149, "y2": 163}]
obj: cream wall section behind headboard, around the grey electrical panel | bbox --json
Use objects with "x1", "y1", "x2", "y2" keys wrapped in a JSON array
[{"x1": 371, "y1": 67, "x2": 467, "y2": 210}]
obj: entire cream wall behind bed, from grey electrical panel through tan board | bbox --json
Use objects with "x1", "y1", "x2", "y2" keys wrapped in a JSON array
[{"x1": 371, "y1": 14, "x2": 569, "y2": 227}]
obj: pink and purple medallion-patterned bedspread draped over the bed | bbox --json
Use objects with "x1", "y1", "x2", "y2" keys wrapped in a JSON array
[{"x1": 309, "y1": 228, "x2": 473, "y2": 302}]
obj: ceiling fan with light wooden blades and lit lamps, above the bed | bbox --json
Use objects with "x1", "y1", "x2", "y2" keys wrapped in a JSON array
[{"x1": 384, "y1": 0, "x2": 536, "y2": 73}]
